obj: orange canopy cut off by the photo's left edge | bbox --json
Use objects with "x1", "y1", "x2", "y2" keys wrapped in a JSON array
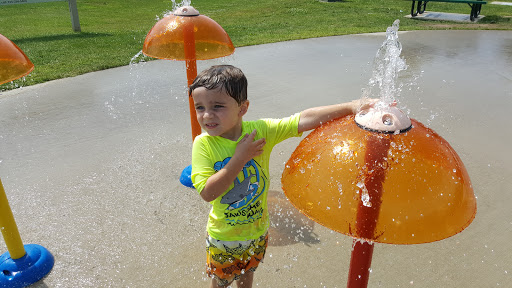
[{"x1": 0, "y1": 34, "x2": 34, "y2": 84}]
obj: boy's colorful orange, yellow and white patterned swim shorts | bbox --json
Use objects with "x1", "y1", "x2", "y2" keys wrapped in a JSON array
[{"x1": 206, "y1": 233, "x2": 268, "y2": 286}]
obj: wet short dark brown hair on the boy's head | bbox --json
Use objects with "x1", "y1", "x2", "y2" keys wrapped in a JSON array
[{"x1": 188, "y1": 65, "x2": 247, "y2": 105}]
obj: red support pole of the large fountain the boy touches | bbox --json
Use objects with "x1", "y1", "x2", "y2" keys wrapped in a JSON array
[{"x1": 347, "y1": 133, "x2": 392, "y2": 288}]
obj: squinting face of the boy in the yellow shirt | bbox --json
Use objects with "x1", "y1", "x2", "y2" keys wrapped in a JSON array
[{"x1": 192, "y1": 87, "x2": 249, "y2": 141}]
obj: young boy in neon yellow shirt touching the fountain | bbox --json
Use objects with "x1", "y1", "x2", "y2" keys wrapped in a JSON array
[{"x1": 189, "y1": 65, "x2": 370, "y2": 288}]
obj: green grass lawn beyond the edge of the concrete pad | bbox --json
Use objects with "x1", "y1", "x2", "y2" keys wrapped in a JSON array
[{"x1": 0, "y1": 0, "x2": 512, "y2": 89}]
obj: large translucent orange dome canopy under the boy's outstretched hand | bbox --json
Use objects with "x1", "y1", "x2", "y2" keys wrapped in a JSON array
[{"x1": 282, "y1": 116, "x2": 476, "y2": 244}]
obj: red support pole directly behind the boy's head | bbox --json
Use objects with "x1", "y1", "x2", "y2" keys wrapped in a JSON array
[{"x1": 183, "y1": 23, "x2": 201, "y2": 140}]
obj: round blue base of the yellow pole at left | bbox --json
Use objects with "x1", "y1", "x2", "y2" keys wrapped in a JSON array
[{"x1": 0, "y1": 244, "x2": 55, "y2": 288}]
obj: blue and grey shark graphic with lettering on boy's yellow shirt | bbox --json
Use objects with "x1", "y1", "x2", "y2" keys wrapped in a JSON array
[{"x1": 214, "y1": 157, "x2": 268, "y2": 226}]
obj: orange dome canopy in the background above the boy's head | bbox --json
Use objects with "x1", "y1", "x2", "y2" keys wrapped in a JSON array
[{"x1": 142, "y1": 6, "x2": 235, "y2": 60}]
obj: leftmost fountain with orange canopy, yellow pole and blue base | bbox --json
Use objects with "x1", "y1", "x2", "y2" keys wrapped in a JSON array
[{"x1": 0, "y1": 34, "x2": 55, "y2": 288}]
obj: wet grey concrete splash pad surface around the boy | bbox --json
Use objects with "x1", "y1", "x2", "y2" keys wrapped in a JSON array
[{"x1": 0, "y1": 31, "x2": 512, "y2": 287}]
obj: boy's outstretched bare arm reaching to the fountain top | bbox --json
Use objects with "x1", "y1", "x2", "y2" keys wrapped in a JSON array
[{"x1": 299, "y1": 99, "x2": 377, "y2": 133}]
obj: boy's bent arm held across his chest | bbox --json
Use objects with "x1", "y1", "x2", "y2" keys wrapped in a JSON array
[{"x1": 201, "y1": 130, "x2": 266, "y2": 202}]
